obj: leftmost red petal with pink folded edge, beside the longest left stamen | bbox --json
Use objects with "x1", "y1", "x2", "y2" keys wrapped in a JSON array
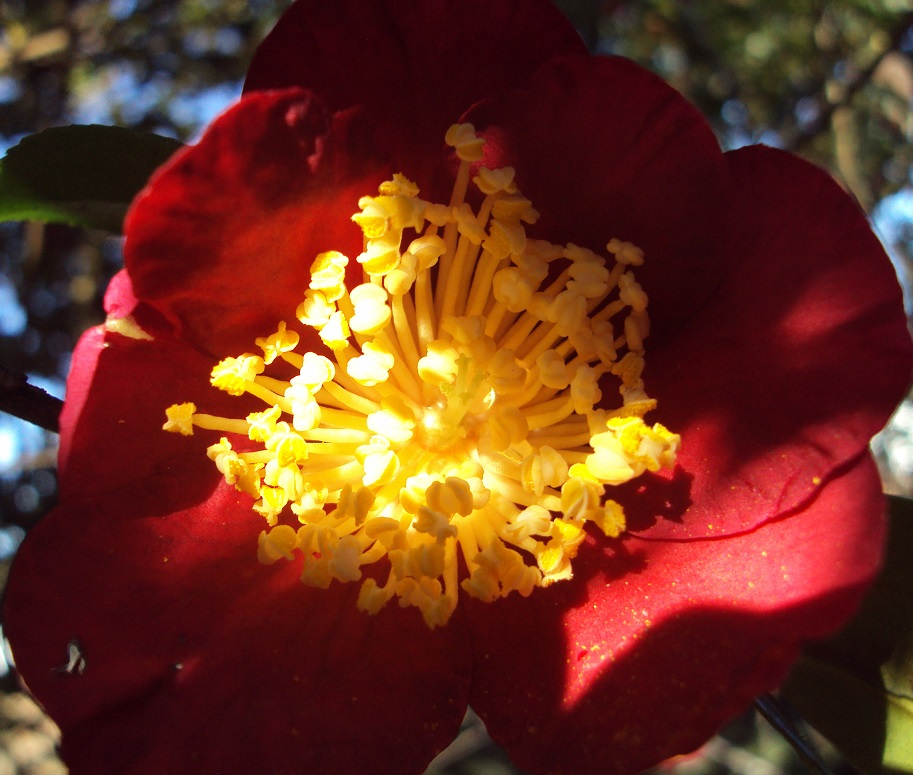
[{"x1": 60, "y1": 326, "x2": 244, "y2": 506}]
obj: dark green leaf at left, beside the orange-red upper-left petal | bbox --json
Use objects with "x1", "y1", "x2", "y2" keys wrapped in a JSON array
[{"x1": 0, "y1": 125, "x2": 182, "y2": 233}]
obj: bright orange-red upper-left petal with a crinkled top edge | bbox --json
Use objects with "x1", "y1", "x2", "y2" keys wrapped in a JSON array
[{"x1": 125, "y1": 90, "x2": 389, "y2": 357}]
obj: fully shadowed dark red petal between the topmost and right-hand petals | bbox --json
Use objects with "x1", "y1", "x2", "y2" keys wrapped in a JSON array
[{"x1": 467, "y1": 57, "x2": 728, "y2": 327}]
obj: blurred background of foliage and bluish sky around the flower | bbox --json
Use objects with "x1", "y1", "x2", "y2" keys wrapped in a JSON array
[{"x1": 0, "y1": 0, "x2": 913, "y2": 775}]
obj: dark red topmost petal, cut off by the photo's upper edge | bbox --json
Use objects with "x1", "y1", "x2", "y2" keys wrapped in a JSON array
[{"x1": 245, "y1": 0, "x2": 585, "y2": 189}]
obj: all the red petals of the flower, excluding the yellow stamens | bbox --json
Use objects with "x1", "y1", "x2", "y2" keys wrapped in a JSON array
[{"x1": 6, "y1": 0, "x2": 911, "y2": 775}]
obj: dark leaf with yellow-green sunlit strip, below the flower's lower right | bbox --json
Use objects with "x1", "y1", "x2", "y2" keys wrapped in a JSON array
[{"x1": 783, "y1": 497, "x2": 913, "y2": 773}]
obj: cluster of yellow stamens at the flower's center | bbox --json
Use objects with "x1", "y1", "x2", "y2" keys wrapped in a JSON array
[{"x1": 164, "y1": 124, "x2": 679, "y2": 627}]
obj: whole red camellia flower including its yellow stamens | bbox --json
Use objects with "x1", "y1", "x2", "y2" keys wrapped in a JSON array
[{"x1": 6, "y1": 0, "x2": 913, "y2": 774}]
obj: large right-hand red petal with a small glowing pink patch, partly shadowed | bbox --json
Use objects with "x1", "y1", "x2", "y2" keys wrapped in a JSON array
[{"x1": 631, "y1": 147, "x2": 913, "y2": 537}]
